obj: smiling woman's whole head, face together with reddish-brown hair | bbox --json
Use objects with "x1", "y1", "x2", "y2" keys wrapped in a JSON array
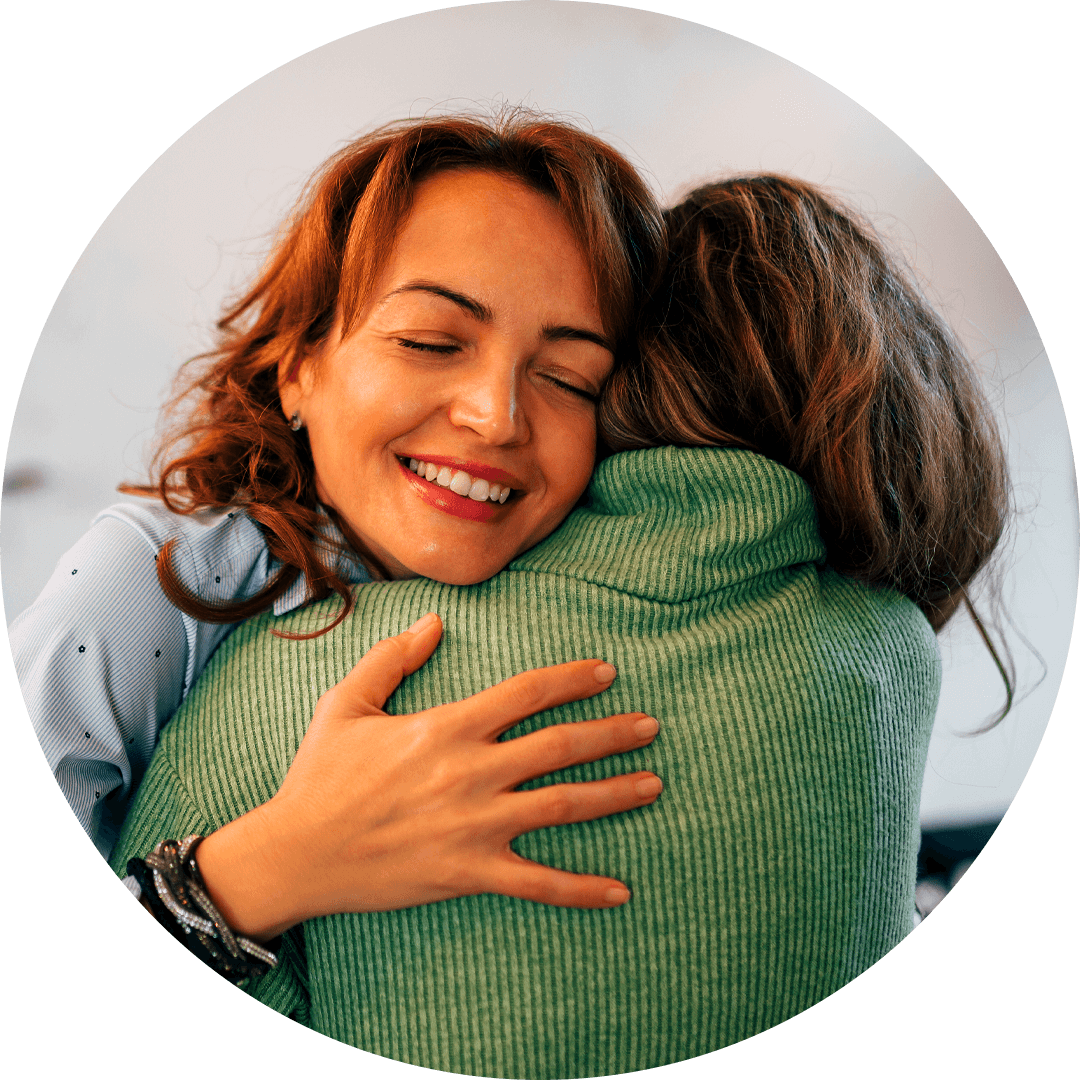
[{"x1": 123, "y1": 111, "x2": 663, "y2": 630}]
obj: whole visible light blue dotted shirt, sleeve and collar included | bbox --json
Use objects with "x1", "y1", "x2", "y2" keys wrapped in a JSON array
[{"x1": 9, "y1": 500, "x2": 372, "y2": 859}]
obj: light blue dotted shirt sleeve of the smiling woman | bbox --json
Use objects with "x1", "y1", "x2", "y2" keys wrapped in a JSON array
[{"x1": 11, "y1": 517, "x2": 212, "y2": 858}]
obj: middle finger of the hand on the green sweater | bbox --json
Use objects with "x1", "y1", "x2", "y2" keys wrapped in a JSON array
[{"x1": 496, "y1": 713, "x2": 660, "y2": 788}]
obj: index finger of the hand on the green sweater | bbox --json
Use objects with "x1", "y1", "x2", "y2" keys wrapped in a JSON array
[{"x1": 455, "y1": 660, "x2": 616, "y2": 740}]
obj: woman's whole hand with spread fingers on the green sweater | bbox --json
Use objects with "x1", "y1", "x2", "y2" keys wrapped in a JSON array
[{"x1": 198, "y1": 615, "x2": 662, "y2": 941}]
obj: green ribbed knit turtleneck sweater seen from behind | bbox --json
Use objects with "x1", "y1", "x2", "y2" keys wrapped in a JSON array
[{"x1": 107, "y1": 448, "x2": 940, "y2": 1078}]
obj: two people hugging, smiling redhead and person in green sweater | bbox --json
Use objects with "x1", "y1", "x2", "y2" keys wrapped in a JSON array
[{"x1": 11, "y1": 110, "x2": 1011, "y2": 1078}]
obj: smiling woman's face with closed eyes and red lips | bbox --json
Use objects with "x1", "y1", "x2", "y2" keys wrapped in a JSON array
[{"x1": 281, "y1": 168, "x2": 613, "y2": 584}]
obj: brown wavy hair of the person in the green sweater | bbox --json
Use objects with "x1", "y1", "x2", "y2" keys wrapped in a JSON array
[{"x1": 597, "y1": 175, "x2": 1012, "y2": 716}]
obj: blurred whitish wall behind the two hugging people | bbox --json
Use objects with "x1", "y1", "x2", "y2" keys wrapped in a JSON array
[{"x1": 0, "y1": 0, "x2": 1078, "y2": 826}]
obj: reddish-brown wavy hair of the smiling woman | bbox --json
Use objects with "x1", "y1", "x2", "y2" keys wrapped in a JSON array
[{"x1": 120, "y1": 109, "x2": 664, "y2": 636}]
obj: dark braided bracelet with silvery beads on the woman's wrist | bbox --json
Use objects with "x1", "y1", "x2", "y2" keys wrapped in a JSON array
[{"x1": 127, "y1": 836, "x2": 281, "y2": 985}]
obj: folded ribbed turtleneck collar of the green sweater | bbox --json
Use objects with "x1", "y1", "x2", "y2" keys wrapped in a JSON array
[{"x1": 509, "y1": 446, "x2": 825, "y2": 603}]
